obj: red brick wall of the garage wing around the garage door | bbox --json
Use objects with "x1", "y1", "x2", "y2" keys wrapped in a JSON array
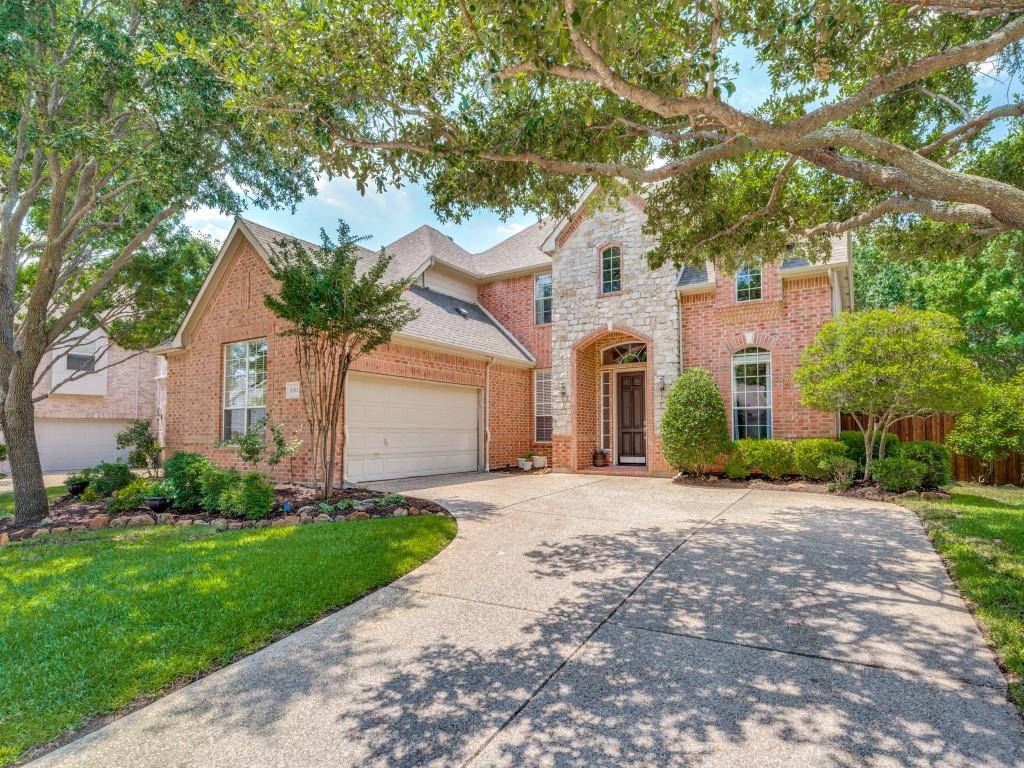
[{"x1": 165, "y1": 241, "x2": 532, "y2": 481}]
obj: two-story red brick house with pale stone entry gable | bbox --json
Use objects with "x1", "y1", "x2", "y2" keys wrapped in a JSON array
[{"x1": 157, "y1": 188, "x2": 852, "y2": 482}]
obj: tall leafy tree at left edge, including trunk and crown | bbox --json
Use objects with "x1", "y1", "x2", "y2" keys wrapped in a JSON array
[{"x1": 0, "y1": 0, "x2": 312, "y2": 521}]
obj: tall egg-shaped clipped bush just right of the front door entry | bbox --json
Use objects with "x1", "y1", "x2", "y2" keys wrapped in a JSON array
[{"x1": 662, "y1": 368, "x2": 729, "y2": 474}]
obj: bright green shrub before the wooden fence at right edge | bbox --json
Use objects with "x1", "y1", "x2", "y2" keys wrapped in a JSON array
[{"x1": 946, "y1": 375, "x2": 1024, "y2": 480}]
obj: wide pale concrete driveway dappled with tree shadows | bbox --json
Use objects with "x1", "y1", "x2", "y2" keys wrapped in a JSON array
[{"x1": 36, "y1": 475, "x2": 1024, "y2": 768}]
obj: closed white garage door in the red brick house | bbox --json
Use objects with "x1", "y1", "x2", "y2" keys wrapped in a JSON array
[{"x1": 345, "y1": 375, "x2": 479, "y2": 482}]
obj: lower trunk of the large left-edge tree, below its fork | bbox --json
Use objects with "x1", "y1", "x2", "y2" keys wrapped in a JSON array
[{"x1": 0, "y1": 360, "x2": 49, "y2": 524}]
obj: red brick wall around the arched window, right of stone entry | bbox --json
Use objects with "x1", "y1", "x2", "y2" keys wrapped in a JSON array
[{"x1": 681, "y1": 266, "x2": 836, "y2": 438}]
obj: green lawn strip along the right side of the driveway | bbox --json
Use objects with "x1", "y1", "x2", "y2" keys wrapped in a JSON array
[{"x1": 907, "y1": 484, "x2": 1024, "y2": 714}]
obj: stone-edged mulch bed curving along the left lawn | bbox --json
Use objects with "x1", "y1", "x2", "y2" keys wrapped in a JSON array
[{"x1": 0, "y1": 484, "x2": 450, "y2": 545}]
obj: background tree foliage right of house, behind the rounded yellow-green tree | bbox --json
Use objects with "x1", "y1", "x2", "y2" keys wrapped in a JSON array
[{"x1": 853, "y1": 232, "x2": 1024, "y2": 381}]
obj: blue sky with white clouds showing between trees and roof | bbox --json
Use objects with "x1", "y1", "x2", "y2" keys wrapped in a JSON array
[{"x1": 185, "y1": 49, "x2": 1020, "y2": 253}]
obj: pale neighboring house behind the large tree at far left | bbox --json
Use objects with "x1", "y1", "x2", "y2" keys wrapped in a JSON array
[{"x1": 2, "y1": 332, "x2": 159, "y2": 472}]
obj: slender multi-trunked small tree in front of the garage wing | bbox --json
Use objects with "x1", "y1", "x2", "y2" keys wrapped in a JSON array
[{"x1": 264, "y1": 221, "x2": 418, "y2": 499}]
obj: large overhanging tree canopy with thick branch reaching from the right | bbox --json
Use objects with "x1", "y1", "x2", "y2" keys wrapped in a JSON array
[{"x1": 192, "y1": 0, "x2": 1024, "y2": 271}]
